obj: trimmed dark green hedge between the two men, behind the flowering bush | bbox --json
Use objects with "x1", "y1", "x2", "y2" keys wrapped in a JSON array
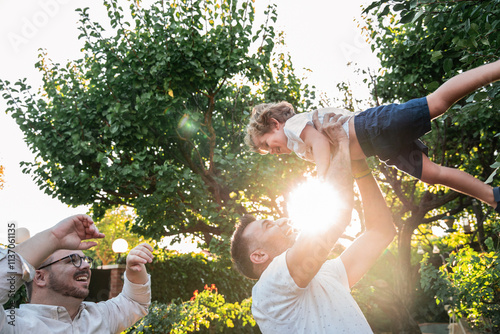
[{"x1": 147, "y1": 250, "x2": 254, "y2": 304}]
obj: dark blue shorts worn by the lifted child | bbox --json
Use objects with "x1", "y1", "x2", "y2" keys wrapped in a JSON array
[{"x1": 354, "y1": 97, "x2": 431, "y2": 179}]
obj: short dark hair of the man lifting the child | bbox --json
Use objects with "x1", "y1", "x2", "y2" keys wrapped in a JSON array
[{"x1": 231, "y1": 214, "x2": 259, "y2": 279}]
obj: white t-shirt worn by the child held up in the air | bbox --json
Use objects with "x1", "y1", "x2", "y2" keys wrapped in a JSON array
[{"x1": 284, "y1": 108, "x2": 353, "y2": 162}]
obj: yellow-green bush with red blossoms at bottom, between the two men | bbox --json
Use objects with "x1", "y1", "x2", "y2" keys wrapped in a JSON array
[{"x1": 126, "y1": 285, "x2": 260, "y2": 334}]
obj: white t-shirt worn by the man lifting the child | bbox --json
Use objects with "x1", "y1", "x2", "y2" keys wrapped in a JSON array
[{"x1": 252, "y1": 252, "x2": 373, "y2": 334}]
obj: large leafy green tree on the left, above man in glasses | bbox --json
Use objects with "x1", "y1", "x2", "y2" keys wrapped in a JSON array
[{"x1": 0, "y1": 0, "x2": 314, "y2": 252}]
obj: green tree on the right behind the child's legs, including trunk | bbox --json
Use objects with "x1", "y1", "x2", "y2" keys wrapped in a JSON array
[{"x1": 365, "y1": 0, "x2": 500, "y2": 333}]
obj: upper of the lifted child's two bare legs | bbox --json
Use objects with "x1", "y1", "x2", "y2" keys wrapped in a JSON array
[{"x1": 427, "y1": 60, "x2": 500, "y2": 119}]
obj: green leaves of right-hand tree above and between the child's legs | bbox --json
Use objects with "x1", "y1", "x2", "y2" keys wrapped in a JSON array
[{"x1": 365, "y1": 0, "x2": 500, "y2": 188}]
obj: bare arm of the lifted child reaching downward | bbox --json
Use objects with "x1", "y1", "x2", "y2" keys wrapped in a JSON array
[{"x1": 300, "y1": 125, "x2": 330, "y2": 180}]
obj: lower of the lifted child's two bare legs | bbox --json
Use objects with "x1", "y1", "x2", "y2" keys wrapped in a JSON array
[{"x1": 421, "y1": 154, "x2": 498, "y2": 208}]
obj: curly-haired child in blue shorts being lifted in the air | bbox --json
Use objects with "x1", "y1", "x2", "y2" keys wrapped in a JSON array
[{"x1": 245, "y1": 60, "x2": 500, "y2": 213}]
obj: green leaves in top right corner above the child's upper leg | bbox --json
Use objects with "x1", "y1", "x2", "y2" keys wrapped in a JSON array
[{"x1": 365, "y1": 0, "x2": 500, "y2": 101}]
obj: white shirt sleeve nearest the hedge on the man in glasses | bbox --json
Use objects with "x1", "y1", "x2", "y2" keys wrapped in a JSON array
[{"x1": 97, "y1": 274, "x2": 151, "y2": 333}]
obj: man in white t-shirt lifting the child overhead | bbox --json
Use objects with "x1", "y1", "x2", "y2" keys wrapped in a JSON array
[{"x1": 231, "y1": 114, "x2": 395, "y2": 334}]
